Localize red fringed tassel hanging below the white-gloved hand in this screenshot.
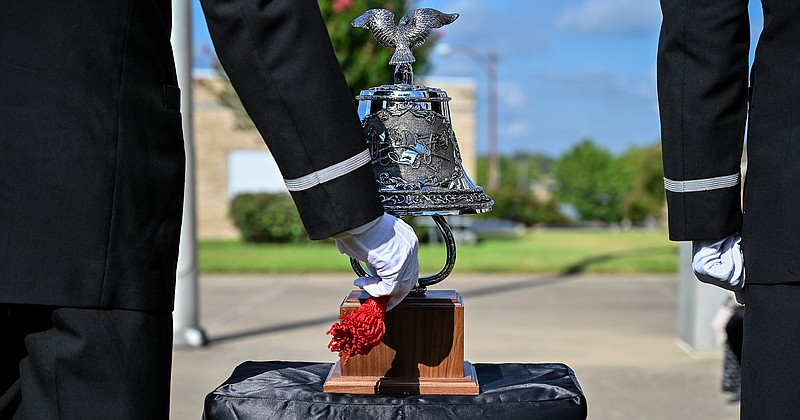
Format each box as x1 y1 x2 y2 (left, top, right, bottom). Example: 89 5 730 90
327 296 389 365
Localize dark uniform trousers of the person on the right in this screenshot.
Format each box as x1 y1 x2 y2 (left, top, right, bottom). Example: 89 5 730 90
741 284 800 420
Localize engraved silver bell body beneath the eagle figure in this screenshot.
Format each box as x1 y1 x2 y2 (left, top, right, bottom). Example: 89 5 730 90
357 65 492 216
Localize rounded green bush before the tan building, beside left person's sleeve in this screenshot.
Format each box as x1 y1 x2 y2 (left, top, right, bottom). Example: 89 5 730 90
230 193 309 243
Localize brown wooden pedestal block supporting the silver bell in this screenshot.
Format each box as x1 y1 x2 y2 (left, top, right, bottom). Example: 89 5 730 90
323 290 479 395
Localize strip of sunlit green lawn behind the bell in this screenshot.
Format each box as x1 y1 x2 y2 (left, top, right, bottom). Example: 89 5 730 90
199 229 678 276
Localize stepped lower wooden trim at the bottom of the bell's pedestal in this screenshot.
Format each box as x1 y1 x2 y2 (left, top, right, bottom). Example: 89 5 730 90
322 361 480 395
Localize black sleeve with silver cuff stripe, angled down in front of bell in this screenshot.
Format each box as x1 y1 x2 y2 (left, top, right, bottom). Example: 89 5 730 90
201 0 383 239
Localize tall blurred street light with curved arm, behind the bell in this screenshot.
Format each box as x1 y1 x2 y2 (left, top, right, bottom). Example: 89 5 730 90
436 44 500 191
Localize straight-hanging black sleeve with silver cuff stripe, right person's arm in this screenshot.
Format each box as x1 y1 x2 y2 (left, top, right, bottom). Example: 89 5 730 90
658 0 750 241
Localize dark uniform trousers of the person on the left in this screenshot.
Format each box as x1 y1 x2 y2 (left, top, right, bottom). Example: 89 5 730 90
0 304 172 419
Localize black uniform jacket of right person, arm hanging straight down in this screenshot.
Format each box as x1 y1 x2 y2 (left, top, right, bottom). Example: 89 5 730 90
658 0 800 283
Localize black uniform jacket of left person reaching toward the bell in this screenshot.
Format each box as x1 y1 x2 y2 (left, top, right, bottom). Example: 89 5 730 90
0 0 383 311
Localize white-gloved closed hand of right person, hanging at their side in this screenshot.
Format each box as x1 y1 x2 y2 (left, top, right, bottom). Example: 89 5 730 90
692 233 745 304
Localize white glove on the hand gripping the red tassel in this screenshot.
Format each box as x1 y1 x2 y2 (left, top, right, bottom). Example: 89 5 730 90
335 213 419 310
